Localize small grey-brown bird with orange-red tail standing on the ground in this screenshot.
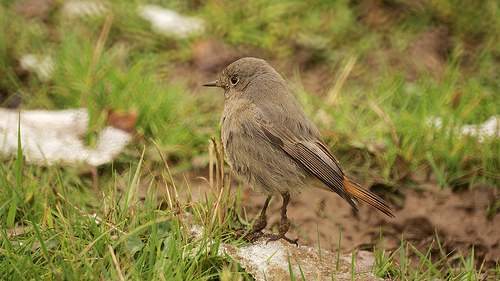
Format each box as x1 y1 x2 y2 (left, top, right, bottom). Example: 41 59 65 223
203 57 394 244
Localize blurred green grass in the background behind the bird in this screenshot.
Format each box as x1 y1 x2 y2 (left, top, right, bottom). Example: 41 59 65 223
0 0 500 187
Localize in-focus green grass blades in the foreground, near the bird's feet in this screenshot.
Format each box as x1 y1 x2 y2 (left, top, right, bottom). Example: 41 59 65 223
0 151 500 280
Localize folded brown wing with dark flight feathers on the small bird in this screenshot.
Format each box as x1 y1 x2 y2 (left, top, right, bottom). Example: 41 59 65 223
256 116 357 210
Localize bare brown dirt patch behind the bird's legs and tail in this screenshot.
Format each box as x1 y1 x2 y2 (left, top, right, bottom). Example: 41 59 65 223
165 166 500 268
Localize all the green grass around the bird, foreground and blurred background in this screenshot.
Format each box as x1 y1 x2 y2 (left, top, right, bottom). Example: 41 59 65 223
0 0 500 280
